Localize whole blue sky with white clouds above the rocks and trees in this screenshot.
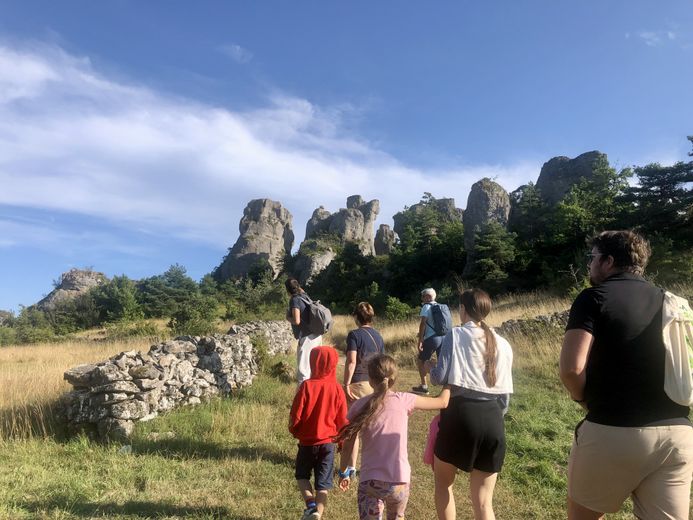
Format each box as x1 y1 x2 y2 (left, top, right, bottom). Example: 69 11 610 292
0 0 693 310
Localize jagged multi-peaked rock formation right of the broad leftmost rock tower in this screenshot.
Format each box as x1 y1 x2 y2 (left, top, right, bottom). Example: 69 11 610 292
294 195 380 284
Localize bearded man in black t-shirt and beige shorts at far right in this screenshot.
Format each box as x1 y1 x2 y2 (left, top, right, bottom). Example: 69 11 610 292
560 231 693 520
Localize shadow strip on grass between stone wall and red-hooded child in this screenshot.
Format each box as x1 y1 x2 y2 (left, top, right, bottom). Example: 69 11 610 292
132 439 294 466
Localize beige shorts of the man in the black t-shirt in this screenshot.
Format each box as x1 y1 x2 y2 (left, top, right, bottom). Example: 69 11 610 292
568 421 693 520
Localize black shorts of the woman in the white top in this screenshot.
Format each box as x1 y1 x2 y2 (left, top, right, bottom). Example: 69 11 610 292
433 397 505 473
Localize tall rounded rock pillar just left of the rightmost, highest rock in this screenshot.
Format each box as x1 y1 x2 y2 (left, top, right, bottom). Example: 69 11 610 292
462 178 510 276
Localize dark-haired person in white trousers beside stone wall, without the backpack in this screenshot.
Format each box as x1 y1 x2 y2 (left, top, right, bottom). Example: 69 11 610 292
284 278 322 385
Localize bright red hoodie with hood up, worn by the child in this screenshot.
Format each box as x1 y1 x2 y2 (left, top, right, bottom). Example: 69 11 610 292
289 347 348 446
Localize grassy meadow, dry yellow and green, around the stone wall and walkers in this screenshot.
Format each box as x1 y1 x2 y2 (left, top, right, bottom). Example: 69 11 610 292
0 294 676 520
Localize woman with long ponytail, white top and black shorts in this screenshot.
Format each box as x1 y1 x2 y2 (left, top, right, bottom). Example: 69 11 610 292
426 289 513 520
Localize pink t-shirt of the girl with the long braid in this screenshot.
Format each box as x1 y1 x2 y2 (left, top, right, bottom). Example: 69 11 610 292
347 392 416 482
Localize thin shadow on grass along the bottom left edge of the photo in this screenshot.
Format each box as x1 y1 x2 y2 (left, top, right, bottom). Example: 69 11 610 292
16 497 254 520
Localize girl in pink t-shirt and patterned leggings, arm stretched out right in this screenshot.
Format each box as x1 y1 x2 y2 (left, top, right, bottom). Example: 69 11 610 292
337 354 450 520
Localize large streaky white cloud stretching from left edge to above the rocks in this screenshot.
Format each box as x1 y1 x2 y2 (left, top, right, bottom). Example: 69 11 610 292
0 40 541 252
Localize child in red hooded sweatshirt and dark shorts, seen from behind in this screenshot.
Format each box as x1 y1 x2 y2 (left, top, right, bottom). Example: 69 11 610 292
289 346 347 520
